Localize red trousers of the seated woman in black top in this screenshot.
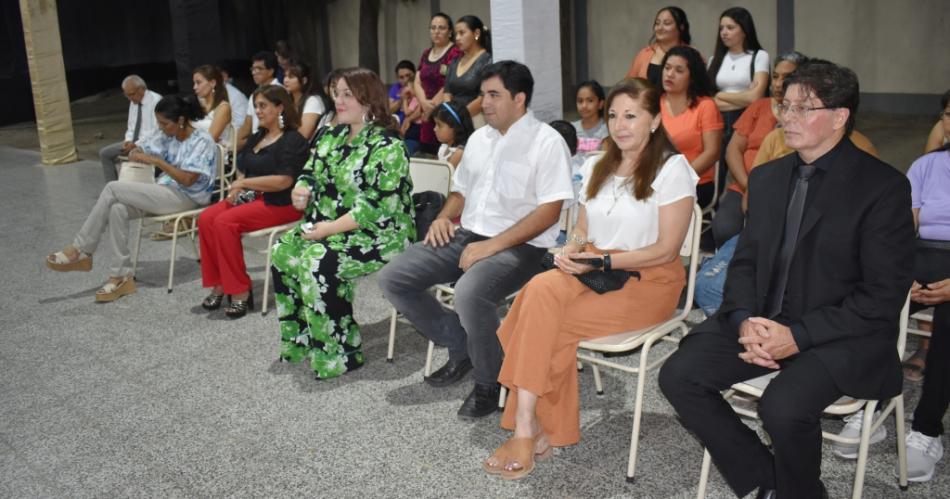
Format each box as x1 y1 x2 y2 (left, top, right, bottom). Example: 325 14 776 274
198 198 301 295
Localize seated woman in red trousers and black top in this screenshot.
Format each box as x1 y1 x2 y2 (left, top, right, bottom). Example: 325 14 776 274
198 85 307 318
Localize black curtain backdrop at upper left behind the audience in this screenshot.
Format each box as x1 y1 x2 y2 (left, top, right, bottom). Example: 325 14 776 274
0 0 333 125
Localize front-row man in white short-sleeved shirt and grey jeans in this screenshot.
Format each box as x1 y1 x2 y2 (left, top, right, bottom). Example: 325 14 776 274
379 61 573 417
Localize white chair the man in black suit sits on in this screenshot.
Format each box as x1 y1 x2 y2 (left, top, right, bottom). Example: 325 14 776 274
696 296 910 499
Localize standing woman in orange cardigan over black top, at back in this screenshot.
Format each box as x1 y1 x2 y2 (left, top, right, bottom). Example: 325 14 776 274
626 6 692 88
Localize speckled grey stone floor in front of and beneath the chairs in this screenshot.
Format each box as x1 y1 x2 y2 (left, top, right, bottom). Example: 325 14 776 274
0 142 950 499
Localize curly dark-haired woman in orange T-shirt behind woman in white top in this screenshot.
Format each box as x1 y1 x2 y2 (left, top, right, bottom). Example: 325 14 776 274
660 45 723 207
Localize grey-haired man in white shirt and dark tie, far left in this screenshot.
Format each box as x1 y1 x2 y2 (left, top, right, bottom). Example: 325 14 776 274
99 75 162 183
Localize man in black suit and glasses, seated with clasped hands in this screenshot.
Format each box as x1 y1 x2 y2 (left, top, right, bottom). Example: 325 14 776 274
659 61 914 499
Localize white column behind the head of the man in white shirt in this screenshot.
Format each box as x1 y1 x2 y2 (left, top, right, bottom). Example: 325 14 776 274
490 0 564 122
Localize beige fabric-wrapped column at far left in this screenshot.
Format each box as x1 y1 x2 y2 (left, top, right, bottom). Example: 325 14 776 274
20 0 78 165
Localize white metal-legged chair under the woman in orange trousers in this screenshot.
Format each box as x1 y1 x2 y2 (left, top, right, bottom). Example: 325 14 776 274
577 205 702 482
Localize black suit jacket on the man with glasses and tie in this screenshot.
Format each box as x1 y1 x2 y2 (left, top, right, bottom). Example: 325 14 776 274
693 139 914 399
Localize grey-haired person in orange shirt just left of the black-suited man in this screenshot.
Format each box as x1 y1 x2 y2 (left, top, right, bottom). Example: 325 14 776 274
712 52 808 248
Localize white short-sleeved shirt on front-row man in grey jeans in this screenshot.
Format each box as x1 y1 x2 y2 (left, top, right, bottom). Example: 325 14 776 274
452 111 574 248
